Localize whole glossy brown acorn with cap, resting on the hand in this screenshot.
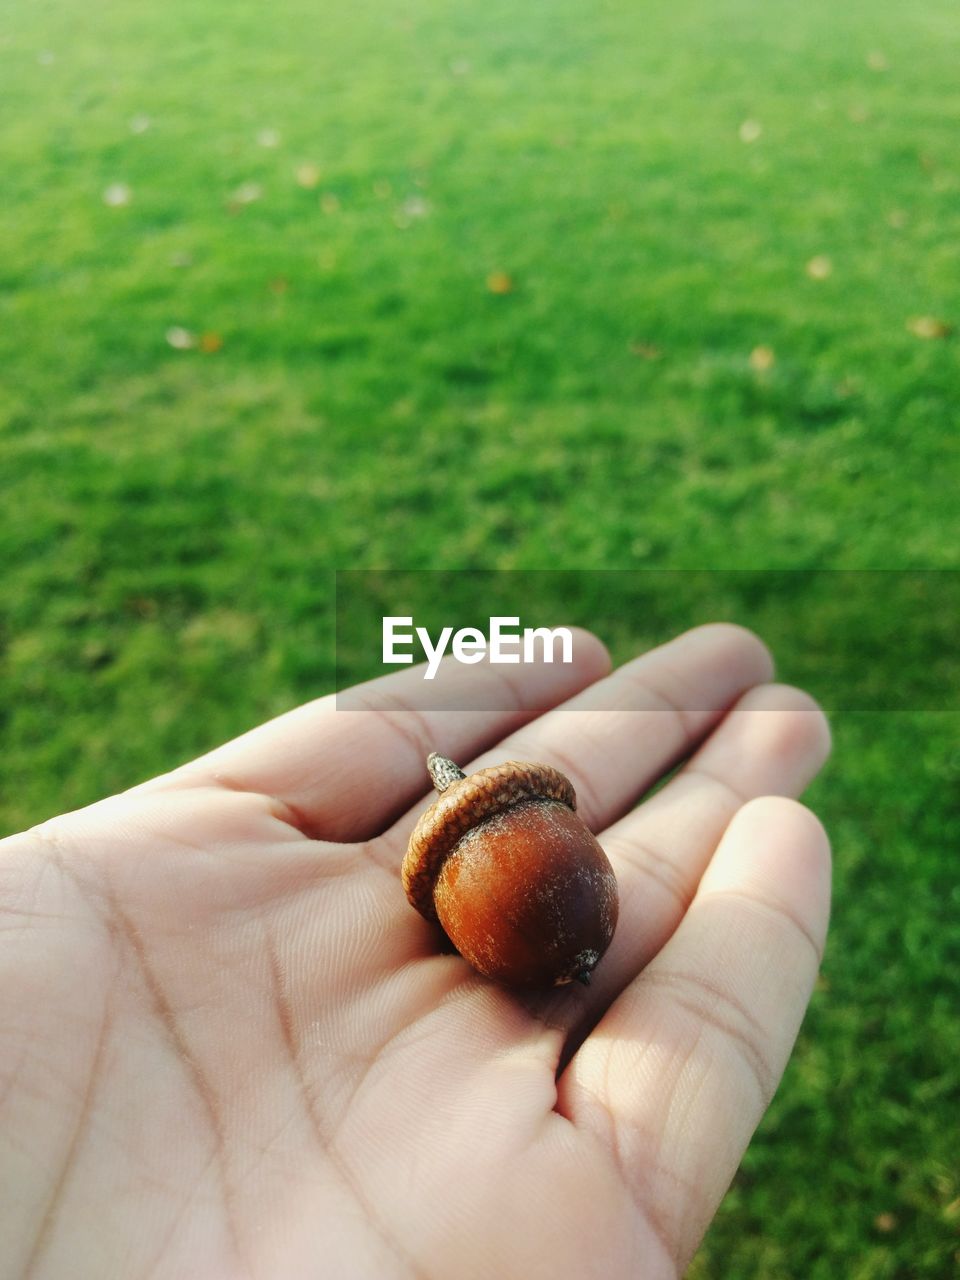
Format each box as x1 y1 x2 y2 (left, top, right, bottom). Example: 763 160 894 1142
402 753 620 987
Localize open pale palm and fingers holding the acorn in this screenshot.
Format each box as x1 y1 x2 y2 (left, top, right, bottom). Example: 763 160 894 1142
0 626 829 1280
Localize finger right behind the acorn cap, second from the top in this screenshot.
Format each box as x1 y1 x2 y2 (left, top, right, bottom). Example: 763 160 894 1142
390 623 773 849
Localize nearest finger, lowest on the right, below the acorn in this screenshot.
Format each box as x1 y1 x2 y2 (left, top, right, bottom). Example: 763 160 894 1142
558 797 829 1271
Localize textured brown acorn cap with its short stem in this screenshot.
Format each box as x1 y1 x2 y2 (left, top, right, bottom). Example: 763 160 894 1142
401 756 577 920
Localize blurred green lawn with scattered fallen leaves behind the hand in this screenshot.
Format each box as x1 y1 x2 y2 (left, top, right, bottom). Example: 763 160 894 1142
0 0 960 1280
